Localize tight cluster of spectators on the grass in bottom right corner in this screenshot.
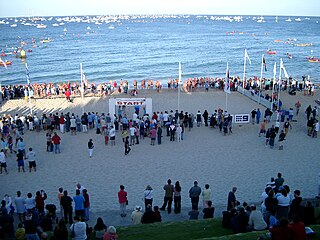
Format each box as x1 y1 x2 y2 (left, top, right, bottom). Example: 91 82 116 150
223 173 320 240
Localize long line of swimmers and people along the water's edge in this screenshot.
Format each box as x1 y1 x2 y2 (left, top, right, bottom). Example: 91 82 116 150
0 77 316 101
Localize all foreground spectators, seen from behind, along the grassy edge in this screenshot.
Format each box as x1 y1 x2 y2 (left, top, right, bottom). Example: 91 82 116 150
0 173 320 240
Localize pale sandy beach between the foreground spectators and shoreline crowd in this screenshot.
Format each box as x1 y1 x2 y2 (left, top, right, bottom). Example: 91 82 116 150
0 89 320 226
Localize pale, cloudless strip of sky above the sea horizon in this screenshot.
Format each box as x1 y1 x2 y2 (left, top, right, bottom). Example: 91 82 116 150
0 0 320 17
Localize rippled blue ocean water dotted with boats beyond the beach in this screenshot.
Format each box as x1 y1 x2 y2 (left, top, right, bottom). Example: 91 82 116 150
0 16 320 84
